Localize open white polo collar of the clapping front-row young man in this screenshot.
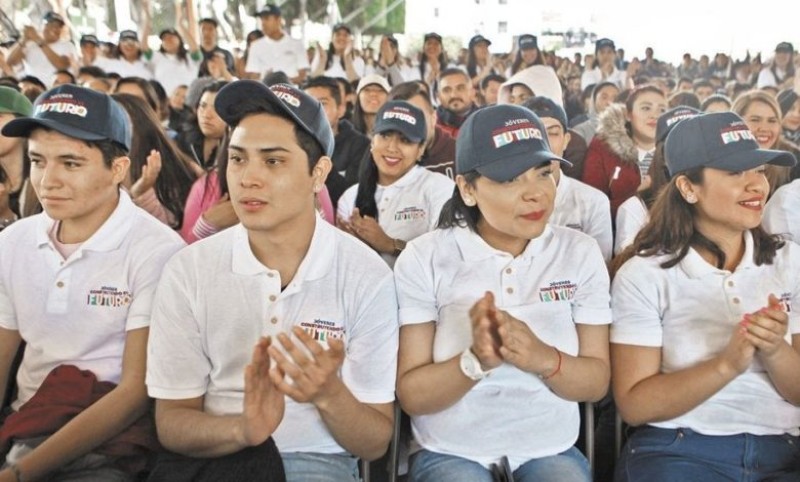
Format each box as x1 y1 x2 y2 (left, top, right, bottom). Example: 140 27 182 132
231 215 337 285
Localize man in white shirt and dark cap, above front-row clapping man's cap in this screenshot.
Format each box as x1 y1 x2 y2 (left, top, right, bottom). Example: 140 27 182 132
245 4 309 85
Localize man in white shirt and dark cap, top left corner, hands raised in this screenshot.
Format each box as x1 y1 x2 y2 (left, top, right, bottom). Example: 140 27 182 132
6 12 78 86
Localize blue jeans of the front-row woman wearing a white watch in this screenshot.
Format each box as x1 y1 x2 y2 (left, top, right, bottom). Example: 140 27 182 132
409 447 592 482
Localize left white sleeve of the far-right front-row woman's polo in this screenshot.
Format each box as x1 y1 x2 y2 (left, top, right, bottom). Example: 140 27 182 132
610 258 663 347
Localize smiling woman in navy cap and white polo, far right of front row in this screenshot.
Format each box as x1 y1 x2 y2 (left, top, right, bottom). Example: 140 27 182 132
611 112 800 482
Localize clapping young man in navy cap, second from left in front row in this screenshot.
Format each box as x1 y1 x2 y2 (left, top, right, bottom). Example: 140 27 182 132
147 80 397 482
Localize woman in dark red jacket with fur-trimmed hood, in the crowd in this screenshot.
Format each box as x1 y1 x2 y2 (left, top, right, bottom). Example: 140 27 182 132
581 85 667 220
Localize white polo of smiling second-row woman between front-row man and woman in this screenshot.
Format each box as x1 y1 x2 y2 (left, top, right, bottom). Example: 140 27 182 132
336 165 455 266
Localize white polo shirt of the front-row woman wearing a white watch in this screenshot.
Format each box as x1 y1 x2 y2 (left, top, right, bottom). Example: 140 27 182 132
394 225 611 469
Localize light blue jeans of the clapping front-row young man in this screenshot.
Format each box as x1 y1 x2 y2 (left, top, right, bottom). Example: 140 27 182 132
281 452 359 482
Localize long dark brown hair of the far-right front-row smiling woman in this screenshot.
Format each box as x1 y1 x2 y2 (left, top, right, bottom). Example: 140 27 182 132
611 167 785 274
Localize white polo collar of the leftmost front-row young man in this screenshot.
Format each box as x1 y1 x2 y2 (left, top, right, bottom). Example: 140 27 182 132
36 189 137 252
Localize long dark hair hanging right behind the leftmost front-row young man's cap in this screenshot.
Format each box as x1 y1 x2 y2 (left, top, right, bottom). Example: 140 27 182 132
113 94 195 229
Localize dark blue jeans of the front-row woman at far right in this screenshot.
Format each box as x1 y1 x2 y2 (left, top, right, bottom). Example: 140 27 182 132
615 426 800 482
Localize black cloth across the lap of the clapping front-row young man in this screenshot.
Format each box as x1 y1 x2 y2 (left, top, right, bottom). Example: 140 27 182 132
147 437 286 482
